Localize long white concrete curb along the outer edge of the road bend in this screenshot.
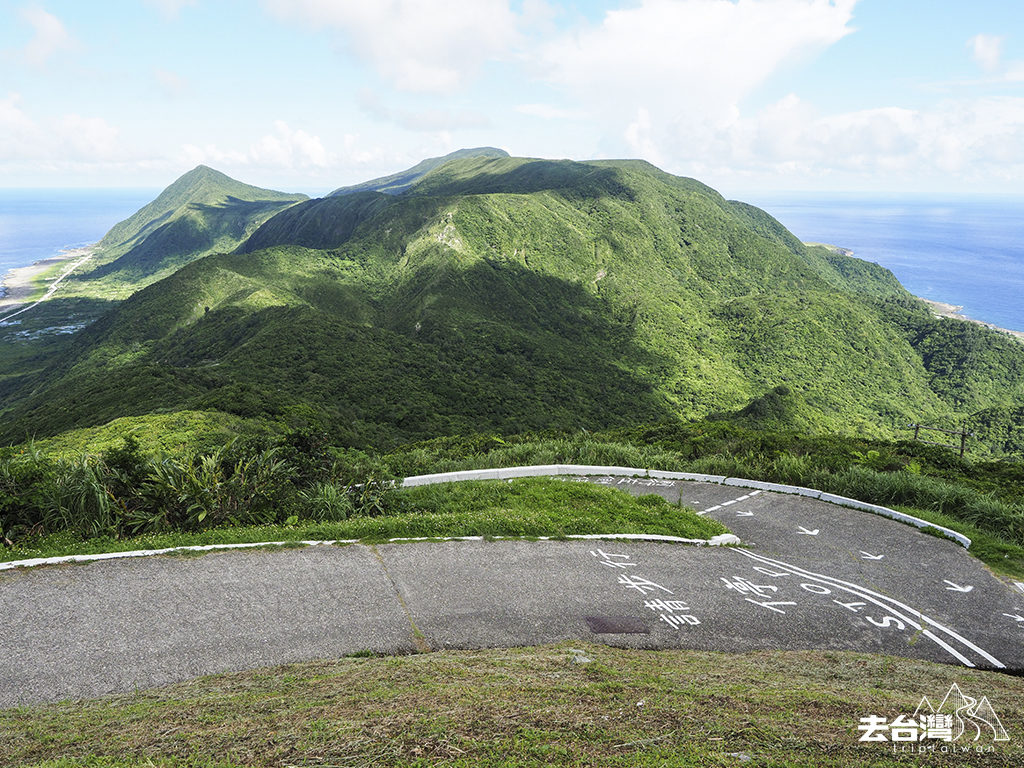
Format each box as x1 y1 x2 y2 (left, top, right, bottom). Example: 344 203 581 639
399 464 971 549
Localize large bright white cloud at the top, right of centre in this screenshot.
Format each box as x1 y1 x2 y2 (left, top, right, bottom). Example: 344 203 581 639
535 0 856 124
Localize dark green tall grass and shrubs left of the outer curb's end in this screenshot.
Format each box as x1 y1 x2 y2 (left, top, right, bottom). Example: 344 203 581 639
0 440 388 545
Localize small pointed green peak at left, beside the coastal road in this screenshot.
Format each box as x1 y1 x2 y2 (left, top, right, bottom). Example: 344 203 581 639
72 165 308 295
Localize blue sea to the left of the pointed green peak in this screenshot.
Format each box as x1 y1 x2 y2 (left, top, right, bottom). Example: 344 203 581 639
0 188 159 278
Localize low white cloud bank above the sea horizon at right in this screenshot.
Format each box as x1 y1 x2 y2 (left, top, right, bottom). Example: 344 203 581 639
688 94 1024 188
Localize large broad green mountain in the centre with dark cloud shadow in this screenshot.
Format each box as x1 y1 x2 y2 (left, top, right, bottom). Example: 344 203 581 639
0 157 1024 456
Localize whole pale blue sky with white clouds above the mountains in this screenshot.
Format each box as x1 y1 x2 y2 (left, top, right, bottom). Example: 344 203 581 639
0 0 1024 197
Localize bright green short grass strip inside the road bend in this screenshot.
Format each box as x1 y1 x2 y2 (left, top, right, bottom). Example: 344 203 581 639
0 478 728 561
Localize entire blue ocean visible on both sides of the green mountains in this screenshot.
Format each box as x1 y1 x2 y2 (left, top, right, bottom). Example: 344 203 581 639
0 189 1024 331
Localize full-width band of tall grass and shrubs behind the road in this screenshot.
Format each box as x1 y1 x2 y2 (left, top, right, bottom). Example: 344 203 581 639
0 426 1024 545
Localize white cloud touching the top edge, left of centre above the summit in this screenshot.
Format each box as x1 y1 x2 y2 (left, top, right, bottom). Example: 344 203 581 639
264 0 524 92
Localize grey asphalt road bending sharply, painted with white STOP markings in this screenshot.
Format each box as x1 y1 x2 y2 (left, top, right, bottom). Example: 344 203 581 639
0 475 1024 707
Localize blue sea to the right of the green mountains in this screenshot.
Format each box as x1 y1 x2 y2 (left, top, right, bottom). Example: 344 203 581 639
748 195 1024 331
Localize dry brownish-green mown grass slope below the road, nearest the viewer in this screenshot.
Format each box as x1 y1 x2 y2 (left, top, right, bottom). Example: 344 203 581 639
0 644 1024 768
